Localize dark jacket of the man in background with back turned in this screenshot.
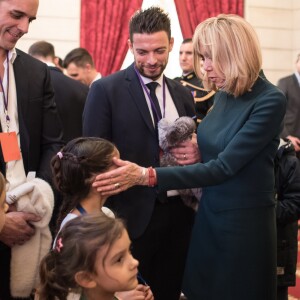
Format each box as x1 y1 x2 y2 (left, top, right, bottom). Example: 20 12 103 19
49 67 89 143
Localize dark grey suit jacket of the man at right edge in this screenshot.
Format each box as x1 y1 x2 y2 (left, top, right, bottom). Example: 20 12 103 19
278 74 300 138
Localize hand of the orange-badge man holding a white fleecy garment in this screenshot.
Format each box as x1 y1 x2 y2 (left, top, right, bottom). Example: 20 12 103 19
0 212 41 247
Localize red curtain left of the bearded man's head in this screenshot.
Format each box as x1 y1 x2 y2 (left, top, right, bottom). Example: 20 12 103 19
80 0 142 76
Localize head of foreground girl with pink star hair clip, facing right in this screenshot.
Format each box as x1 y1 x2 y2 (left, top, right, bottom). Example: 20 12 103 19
37 213 138 300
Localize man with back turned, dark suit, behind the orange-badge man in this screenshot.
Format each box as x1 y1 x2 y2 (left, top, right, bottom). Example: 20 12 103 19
28 41 89 143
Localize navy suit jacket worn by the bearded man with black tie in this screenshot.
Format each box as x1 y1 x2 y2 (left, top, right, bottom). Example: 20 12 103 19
83 65 195 238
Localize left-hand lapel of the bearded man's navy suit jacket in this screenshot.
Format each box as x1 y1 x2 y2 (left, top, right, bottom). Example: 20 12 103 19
125 64 156 136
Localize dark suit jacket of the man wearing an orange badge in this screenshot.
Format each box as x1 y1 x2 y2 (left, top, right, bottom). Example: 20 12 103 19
0 50 62 182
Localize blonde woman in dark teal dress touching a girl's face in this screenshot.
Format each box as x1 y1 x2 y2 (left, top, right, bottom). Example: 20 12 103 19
94 15 286 300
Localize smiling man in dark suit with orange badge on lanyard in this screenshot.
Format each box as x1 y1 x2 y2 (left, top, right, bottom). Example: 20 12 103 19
0 0 62 300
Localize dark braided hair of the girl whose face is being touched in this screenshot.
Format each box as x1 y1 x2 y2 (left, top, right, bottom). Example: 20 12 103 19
51 137 116 229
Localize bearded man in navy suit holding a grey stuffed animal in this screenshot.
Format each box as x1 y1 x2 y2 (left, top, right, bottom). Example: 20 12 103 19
83 7 199 300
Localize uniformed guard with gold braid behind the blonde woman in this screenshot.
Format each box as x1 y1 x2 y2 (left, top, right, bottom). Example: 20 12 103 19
174 38 215 123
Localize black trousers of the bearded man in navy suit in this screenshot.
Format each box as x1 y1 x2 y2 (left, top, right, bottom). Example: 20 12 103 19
132 196 195 300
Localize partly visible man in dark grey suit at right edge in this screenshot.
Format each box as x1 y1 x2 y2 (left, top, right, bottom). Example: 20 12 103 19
278 54 300 158
